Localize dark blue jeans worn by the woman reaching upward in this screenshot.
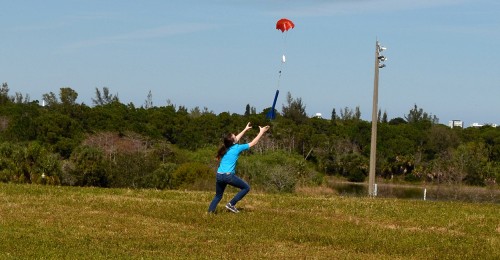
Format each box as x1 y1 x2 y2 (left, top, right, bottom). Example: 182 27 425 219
208 173 250 212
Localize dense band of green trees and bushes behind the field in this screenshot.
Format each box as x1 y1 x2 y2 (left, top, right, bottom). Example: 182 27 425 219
0 83 500 191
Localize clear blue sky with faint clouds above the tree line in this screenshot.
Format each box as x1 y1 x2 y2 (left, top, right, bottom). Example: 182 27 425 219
0 0 500 126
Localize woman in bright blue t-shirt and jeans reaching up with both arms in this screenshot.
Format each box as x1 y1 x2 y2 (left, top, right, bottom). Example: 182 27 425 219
208 123 269 213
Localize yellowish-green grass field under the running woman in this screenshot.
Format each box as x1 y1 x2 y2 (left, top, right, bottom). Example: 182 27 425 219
0 184 500 259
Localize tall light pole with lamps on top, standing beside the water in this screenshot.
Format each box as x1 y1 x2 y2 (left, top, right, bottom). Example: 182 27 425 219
368 40 387 197
